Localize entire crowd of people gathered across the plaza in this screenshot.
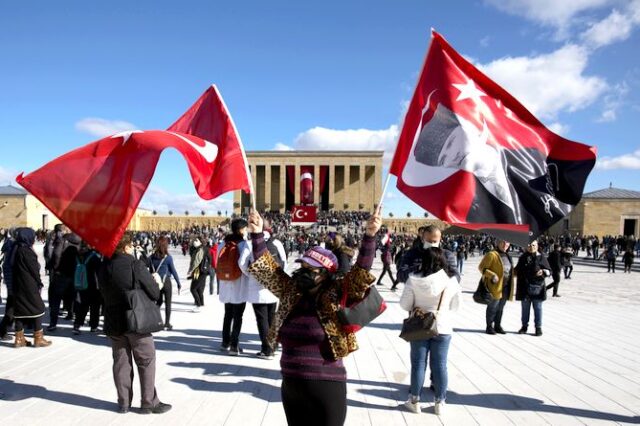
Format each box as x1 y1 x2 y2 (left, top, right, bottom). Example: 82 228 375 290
0 216 640 425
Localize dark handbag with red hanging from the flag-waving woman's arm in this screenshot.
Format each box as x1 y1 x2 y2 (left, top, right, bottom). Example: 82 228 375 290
337 282 387 333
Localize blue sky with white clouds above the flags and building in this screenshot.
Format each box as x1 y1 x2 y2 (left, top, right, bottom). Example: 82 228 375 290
0 0 640 215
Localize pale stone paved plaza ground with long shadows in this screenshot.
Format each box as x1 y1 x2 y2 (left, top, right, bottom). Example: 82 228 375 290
0 243 640 426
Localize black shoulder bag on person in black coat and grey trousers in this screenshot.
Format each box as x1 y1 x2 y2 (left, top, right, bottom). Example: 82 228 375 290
126 261 164 334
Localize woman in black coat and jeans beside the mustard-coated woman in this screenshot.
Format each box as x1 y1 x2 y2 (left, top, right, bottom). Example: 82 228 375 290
515 241 551 336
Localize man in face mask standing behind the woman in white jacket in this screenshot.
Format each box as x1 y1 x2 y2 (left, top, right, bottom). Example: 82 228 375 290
391 225 460 291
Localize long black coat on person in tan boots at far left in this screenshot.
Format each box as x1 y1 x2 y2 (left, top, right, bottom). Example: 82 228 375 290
12 245 45 318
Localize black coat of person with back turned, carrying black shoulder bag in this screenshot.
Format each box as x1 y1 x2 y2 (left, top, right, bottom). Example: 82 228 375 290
99 253 160 336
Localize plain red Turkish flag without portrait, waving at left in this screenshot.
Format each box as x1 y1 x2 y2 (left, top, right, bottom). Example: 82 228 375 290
16 86 250 256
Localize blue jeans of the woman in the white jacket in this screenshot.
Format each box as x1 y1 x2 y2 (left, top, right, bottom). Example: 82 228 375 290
409 334 451 401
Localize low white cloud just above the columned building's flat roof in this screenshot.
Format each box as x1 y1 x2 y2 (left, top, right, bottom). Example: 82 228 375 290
294 124 399 166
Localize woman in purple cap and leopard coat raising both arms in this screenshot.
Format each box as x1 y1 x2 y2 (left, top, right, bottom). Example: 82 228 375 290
249 209 382 426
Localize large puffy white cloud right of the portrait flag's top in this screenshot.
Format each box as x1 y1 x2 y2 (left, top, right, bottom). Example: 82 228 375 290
478 44 608 118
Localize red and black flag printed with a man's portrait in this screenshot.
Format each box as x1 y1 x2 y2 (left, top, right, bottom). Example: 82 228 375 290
390 32 596 245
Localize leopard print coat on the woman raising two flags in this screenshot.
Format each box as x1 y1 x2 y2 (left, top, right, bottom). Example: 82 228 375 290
249 252 375 360
